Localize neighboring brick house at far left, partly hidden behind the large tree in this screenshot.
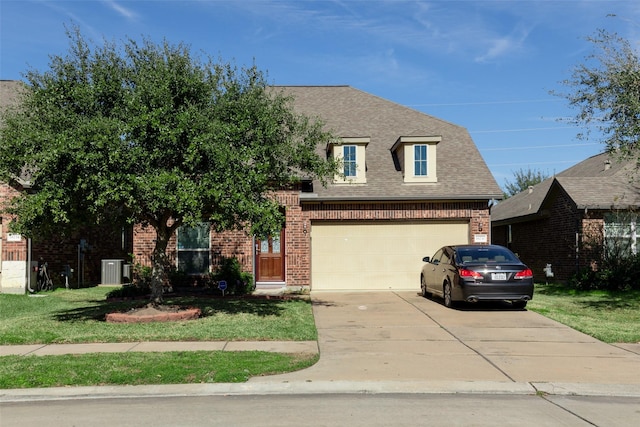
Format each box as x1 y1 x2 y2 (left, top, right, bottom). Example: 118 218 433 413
0 80 132 293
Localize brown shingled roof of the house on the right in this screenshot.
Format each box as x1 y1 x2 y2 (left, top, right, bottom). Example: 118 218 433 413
491 153 640 224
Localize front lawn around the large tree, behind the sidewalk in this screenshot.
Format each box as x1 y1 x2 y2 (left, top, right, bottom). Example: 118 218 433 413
0 287 317 344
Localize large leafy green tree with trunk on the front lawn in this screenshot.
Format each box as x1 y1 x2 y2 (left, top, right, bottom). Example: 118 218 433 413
0 28 337 303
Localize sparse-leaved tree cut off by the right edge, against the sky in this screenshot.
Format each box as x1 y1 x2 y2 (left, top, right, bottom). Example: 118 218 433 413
554 30 640 165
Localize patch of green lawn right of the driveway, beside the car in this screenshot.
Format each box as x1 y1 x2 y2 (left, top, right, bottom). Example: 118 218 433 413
527 284 640 343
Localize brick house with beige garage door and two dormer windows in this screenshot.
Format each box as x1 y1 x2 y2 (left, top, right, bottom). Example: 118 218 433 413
134 86 502 291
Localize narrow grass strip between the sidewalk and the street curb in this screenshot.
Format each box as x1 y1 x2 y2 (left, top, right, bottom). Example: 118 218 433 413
0 351 318 389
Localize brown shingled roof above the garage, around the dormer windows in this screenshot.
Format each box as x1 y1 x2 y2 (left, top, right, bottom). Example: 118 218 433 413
277 86 502 200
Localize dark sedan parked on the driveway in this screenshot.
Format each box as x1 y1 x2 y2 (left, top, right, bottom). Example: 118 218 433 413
420 245 533 308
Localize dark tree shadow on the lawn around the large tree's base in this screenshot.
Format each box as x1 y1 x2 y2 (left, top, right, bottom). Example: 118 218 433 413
54 296 302 322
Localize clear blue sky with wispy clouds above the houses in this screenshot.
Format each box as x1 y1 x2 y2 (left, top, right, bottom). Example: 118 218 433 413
0 0 640 191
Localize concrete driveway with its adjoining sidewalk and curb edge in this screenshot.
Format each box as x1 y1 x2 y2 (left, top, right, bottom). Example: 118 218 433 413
0 291 640 402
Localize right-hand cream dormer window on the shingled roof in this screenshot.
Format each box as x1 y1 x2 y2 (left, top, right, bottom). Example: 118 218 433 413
391 136 442 183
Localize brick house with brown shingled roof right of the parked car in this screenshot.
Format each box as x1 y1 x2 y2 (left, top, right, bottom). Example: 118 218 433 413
491 154 640 281
